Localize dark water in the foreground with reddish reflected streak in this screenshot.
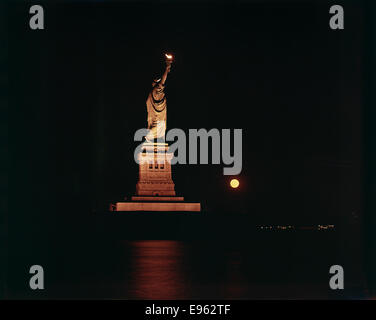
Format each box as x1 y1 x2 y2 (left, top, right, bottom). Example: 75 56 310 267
7 226 365 299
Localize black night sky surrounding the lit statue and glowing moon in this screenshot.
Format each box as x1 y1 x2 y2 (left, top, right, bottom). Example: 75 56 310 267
9 1 364 230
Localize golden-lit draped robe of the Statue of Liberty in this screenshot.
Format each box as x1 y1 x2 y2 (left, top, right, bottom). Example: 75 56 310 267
145 83 167 142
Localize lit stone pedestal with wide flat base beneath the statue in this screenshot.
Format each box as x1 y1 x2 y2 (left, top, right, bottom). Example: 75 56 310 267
110 142 201 212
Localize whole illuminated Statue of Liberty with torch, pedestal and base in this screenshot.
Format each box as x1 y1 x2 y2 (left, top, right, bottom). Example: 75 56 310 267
110 54 201 212
